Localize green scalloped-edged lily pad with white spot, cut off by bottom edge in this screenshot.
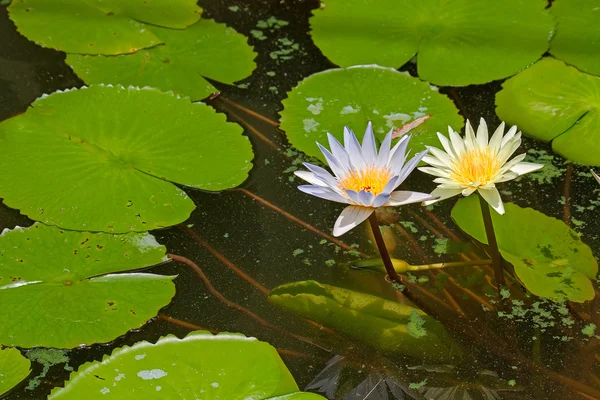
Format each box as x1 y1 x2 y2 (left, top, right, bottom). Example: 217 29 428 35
48 331 323 400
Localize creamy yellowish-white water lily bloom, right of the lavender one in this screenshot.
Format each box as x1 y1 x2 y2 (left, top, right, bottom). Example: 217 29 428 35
419 118 544 214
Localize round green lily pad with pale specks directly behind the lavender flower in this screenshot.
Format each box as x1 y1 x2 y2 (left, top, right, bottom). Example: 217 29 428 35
281 65 463 161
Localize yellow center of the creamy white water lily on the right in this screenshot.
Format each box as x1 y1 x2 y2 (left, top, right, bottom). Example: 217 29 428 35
451 147 502 186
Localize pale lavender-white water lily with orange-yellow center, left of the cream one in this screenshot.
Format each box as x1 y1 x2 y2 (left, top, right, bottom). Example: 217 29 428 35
295 122 434 236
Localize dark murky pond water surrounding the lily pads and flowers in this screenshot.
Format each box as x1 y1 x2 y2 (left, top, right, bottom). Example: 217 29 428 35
0 0 600 400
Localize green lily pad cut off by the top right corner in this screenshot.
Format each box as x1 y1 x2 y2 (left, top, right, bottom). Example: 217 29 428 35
550 0 600 75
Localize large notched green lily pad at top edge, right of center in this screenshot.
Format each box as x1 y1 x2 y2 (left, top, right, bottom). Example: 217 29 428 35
310 0 554 86
